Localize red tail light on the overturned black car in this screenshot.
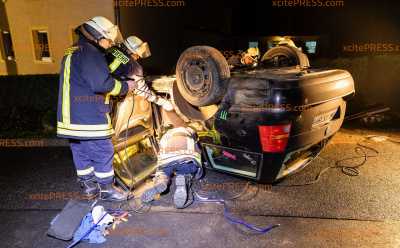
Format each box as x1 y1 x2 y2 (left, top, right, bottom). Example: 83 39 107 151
258 124 291 152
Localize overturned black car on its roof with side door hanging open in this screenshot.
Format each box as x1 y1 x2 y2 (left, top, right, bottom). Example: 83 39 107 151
113 45 354 189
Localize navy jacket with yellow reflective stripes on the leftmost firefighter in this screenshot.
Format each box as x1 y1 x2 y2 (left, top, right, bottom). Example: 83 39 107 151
57 37 128 140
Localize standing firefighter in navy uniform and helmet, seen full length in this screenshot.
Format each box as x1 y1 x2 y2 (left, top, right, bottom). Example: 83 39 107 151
57 16 135 201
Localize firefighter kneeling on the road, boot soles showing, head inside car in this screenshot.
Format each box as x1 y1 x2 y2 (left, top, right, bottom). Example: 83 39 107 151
141 127 203 208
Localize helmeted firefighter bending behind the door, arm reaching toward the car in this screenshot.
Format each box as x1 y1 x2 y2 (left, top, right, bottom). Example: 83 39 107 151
106 36 173 111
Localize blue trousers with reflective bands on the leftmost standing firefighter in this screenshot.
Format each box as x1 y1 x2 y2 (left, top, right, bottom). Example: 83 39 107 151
70 139 114 184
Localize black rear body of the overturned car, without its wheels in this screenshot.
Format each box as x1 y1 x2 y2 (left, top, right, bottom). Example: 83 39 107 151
205 68 354 183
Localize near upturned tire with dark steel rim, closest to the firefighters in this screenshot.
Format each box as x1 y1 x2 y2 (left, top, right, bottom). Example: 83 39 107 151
176 46 230 107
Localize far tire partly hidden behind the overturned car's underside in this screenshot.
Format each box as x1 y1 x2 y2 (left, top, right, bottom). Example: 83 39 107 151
261 45 310 68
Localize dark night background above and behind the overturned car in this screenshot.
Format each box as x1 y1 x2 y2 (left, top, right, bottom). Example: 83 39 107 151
119 0 400 111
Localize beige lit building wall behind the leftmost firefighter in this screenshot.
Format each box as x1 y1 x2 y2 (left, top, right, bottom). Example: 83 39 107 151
4 0 115 74
